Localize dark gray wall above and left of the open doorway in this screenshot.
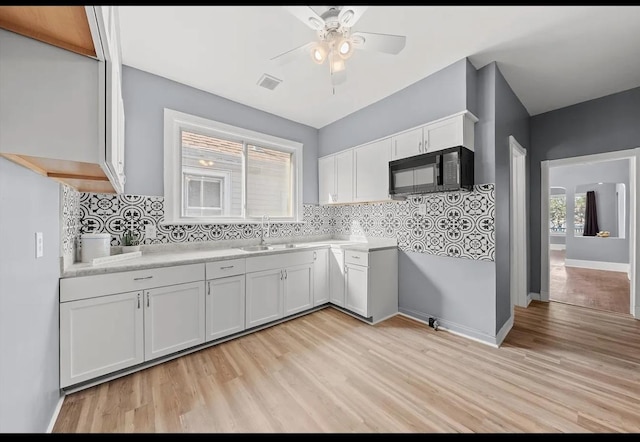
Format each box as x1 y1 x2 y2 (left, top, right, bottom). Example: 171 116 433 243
529 88 640 292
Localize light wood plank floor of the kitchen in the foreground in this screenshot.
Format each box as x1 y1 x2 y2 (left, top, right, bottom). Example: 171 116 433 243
54 301 640 433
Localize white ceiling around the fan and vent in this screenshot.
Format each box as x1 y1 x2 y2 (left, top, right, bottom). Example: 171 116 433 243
119 6 640 128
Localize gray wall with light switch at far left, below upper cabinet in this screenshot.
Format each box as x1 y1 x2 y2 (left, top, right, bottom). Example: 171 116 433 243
0 158 60 433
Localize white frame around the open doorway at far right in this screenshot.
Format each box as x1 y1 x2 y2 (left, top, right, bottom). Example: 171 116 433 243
540 147 640 319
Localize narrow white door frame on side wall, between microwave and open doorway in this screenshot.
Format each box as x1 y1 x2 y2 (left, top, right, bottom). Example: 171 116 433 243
509 135 531 313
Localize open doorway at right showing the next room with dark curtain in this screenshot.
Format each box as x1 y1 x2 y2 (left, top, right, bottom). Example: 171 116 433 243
541 149 639 317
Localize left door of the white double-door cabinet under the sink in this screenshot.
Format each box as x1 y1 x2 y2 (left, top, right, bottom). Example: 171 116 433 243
245 269 284 328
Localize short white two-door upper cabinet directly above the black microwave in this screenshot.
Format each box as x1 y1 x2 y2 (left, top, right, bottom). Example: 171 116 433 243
391 111 478 160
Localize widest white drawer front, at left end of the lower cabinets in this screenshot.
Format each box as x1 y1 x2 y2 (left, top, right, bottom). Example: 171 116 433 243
60 263 204 302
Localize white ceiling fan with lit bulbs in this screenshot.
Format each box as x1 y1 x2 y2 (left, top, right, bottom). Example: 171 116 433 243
271 6 407 93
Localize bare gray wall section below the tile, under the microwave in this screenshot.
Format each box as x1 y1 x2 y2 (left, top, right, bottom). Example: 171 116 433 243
398 250 496 341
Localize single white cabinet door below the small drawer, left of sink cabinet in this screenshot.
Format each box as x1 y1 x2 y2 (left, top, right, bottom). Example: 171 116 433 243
205 275 245 341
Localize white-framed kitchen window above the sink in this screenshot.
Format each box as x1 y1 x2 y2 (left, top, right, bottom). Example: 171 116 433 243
164 109 302 224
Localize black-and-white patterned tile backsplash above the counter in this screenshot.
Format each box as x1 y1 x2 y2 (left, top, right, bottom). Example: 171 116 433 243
75 184 495 261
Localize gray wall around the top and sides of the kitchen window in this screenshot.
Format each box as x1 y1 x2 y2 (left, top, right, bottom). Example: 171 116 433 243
122 66 318 204
